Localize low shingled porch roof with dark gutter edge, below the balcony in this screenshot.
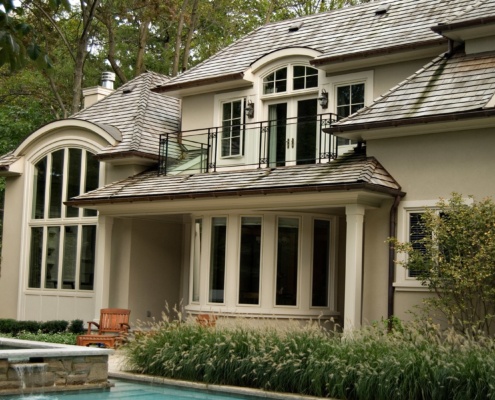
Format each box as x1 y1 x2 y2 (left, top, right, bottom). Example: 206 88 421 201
67 152 402 206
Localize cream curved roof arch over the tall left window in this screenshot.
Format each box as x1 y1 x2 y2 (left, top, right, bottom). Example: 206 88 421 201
13 119 122 156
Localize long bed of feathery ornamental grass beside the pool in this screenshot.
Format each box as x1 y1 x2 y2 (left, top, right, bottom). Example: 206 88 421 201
124 319 495 399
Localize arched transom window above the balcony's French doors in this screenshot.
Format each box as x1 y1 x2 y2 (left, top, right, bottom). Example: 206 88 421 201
263 65 318 94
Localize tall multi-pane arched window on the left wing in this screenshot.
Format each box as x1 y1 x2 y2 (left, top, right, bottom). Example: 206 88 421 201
27 148 100 290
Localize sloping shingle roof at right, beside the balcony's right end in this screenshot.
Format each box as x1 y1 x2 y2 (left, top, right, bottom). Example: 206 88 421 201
330 49 495 132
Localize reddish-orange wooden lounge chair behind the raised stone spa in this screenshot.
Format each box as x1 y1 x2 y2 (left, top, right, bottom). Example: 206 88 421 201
77 308 131 348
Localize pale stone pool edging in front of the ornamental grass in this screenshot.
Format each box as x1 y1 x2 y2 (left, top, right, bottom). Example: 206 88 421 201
108 371 337 400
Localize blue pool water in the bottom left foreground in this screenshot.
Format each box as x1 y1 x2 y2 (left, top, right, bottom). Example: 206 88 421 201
0 379 261 400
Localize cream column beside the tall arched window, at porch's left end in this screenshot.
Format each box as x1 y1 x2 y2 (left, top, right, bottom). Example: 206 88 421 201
94 216 113 319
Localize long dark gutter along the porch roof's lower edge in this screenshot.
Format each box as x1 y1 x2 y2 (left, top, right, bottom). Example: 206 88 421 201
64 182 405 207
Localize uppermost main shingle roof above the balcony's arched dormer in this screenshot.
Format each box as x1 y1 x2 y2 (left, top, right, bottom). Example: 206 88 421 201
156 0 480 92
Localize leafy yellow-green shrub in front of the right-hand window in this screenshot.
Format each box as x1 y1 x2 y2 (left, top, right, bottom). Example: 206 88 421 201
392 193 495 334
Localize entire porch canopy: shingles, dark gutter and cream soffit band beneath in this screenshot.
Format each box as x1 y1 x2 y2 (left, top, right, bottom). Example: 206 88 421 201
66 151 404 212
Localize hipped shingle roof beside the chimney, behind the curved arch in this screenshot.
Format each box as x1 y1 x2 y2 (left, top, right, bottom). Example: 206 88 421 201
71 72 180 157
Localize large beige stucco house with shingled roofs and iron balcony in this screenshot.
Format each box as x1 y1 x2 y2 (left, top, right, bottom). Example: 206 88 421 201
0 0 495 328
